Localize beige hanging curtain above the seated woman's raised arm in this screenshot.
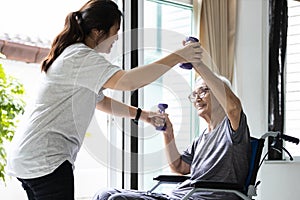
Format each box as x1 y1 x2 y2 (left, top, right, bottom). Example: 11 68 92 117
193 0 237 82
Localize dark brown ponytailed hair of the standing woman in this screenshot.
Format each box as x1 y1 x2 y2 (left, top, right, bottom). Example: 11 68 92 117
41 0 122 72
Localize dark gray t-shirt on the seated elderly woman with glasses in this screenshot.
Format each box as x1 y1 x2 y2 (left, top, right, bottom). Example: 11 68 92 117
172 112 251 200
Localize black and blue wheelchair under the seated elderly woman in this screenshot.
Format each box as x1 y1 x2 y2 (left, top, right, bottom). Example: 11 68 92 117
148 132 299 200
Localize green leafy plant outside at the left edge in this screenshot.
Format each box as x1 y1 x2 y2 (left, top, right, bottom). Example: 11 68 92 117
0 63 25 182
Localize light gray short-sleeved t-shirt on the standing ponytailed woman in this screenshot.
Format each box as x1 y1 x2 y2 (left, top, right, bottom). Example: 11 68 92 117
6 43 120 178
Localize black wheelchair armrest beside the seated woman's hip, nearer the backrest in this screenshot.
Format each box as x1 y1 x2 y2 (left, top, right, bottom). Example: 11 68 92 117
191 180 244 192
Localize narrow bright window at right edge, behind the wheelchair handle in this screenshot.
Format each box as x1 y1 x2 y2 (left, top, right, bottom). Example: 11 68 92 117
285 0 300 156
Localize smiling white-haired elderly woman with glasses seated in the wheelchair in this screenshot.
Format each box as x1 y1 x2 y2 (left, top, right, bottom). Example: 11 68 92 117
95 52 251 200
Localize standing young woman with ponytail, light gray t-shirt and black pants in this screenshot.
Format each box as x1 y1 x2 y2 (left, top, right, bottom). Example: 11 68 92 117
7 0 201 200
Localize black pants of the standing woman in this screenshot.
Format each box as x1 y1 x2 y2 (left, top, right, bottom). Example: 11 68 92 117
18 161 74 200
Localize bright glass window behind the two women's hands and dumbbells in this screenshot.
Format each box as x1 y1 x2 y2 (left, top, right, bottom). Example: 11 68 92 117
139 0 195 189
